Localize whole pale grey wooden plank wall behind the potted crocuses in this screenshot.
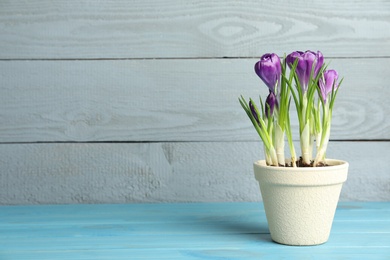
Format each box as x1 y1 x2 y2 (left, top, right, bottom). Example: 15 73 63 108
0 0 390 204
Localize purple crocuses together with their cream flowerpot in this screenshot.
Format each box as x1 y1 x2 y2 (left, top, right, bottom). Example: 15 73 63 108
239 51 348 245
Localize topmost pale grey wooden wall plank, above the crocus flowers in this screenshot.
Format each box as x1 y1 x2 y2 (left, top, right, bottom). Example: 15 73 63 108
0 0 390 59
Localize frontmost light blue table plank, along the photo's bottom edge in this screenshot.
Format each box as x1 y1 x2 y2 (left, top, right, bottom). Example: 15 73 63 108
1 246 389 260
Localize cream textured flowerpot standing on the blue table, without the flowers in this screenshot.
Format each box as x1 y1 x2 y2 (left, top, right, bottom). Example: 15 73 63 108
254 159 348 245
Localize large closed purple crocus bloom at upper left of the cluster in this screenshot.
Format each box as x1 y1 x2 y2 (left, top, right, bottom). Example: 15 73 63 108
255 53 282 93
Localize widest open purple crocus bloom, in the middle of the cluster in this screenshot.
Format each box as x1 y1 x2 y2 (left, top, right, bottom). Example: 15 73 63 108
286 51 324 93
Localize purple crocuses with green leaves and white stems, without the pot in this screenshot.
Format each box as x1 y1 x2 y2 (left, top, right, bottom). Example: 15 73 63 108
239 51 342 167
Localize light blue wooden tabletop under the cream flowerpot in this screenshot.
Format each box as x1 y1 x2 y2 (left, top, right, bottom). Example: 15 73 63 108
0 202 390 260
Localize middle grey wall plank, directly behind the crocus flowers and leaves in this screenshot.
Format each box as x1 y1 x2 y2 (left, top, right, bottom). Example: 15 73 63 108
0 59 390 142
